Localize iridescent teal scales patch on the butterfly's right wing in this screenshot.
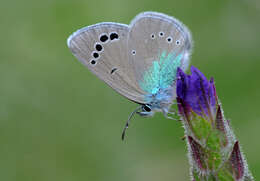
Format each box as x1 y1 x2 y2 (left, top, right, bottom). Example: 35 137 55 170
139 51 182 95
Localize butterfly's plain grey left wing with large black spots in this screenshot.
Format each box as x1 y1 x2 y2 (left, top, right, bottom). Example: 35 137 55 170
67 23 143 103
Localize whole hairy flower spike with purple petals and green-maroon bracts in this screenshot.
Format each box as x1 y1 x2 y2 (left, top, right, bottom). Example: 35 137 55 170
176 67 254 181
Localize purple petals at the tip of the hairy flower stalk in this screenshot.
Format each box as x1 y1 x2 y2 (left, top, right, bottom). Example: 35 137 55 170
177 66 217 119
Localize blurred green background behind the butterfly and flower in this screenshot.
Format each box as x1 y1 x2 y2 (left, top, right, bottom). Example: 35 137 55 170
0 0 260 181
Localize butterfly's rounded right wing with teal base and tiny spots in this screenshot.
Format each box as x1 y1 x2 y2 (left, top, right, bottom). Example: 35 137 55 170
128 12 192 94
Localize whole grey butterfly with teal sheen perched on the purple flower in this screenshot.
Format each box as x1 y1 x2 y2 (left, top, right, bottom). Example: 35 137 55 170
67 12 192 139
